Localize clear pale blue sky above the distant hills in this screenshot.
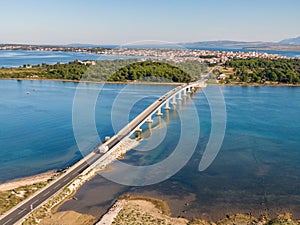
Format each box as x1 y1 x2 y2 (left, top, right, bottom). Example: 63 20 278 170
0 0 300 45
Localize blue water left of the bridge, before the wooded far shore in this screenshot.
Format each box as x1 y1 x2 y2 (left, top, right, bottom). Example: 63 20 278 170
0 80 171 182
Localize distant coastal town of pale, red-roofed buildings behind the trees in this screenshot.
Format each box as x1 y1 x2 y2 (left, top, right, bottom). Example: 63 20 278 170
0 45 287 64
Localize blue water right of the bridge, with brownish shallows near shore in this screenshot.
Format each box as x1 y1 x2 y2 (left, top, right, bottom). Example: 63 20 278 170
60 82 300 220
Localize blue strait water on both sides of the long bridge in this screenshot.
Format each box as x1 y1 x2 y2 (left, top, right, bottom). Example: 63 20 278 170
0 80 300 218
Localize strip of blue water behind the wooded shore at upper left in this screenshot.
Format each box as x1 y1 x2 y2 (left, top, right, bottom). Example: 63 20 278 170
0 50 132 68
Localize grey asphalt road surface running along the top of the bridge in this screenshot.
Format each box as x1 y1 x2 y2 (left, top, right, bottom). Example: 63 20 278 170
0 84 198 225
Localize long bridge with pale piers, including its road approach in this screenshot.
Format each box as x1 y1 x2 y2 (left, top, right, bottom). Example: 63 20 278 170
0 78 209 225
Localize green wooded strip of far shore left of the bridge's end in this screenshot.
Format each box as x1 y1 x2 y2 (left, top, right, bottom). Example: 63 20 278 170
0 59 206 82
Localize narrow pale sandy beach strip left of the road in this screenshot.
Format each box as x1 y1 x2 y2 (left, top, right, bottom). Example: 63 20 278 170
0 171 57 191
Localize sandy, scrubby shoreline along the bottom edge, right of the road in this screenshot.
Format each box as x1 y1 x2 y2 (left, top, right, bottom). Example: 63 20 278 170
96 195 300 225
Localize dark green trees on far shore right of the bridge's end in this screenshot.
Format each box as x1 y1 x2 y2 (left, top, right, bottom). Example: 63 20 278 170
218 58 300 84
